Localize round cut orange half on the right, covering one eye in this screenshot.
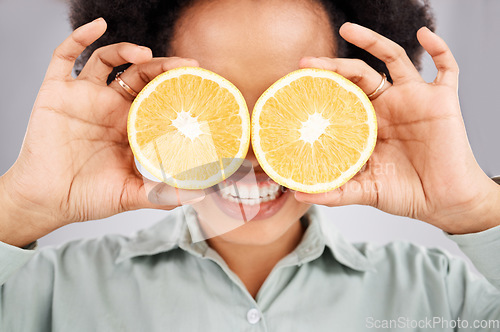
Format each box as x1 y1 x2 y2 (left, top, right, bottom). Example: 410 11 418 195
252 68 377 193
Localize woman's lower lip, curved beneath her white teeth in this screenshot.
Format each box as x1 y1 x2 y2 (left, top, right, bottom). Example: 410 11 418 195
213 187 290 222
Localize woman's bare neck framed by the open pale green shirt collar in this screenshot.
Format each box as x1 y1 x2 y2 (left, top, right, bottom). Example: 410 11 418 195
207 220 304 298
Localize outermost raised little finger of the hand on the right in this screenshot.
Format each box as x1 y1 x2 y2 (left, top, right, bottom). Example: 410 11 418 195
417 27 459 88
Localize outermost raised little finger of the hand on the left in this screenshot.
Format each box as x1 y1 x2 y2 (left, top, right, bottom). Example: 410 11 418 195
45 18 107 79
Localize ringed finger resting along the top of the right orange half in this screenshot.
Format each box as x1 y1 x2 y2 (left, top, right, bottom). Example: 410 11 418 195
299 57 391 100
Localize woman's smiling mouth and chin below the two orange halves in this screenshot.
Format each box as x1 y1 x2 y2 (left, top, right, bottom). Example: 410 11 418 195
193 175 311 246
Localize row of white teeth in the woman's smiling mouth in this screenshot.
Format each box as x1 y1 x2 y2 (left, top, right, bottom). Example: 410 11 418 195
219 183 281 205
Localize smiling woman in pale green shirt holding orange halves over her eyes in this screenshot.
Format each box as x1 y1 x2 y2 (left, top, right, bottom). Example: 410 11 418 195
0 0 500 331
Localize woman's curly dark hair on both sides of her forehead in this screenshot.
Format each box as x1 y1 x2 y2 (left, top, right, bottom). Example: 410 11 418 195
70 0 434 82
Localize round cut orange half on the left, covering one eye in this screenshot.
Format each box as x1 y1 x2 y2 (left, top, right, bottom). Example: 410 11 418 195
127 67 250 189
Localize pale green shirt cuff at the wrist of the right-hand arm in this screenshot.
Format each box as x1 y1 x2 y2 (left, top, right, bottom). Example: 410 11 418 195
445 226 500 290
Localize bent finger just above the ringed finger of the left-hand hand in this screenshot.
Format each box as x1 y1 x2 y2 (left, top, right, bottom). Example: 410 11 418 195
78 42 153 85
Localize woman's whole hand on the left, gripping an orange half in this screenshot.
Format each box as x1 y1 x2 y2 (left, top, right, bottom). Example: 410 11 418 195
0 19 204 246
